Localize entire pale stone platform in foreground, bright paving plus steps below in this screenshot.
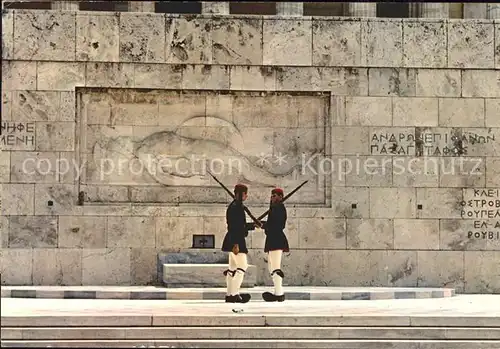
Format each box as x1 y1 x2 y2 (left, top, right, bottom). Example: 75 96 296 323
1 295 500 349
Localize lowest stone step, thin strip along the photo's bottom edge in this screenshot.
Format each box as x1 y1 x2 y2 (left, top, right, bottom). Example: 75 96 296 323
1 339 500 349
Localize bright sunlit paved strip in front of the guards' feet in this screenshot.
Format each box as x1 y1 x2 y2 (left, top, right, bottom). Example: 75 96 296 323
1 295 500 322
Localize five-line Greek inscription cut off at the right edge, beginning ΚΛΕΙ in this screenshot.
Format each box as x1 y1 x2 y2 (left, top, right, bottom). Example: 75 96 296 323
461 189 500 240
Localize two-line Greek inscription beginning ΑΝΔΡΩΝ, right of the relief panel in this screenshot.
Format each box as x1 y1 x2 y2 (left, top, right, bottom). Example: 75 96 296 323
370 127 495 156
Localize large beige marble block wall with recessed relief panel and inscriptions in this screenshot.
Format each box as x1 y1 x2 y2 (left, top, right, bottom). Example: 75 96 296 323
0 10 500 293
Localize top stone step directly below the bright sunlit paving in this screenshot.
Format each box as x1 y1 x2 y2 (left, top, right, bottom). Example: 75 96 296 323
0 312 500 328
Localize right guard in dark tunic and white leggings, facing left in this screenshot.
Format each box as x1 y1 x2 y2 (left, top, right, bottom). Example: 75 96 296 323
262 188 290 302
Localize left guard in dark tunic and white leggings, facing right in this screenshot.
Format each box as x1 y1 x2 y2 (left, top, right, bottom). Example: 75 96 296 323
222 184 257 303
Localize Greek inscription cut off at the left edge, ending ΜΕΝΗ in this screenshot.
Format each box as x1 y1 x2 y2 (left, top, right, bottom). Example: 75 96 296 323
0 121 35 150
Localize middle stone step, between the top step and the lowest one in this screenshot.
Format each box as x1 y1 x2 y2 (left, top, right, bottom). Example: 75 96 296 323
1 326 500 340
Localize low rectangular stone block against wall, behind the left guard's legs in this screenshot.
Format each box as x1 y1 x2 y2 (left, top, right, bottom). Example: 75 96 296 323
162 263 257 287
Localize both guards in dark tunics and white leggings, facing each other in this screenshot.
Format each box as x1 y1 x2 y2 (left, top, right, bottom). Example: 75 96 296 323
222 184 289 303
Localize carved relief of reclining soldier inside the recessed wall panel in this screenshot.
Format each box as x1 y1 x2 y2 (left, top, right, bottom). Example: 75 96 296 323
83 117 323 204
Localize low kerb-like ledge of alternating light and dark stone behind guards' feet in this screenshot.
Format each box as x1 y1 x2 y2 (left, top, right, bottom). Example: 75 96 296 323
1 286 455 300
